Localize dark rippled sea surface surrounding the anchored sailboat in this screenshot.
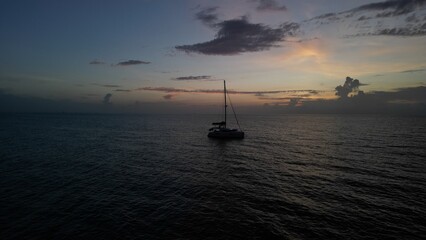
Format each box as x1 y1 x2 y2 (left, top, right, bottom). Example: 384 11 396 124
0 114 426 239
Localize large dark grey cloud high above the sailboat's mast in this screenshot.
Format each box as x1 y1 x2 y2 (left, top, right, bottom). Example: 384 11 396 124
175 17 299 55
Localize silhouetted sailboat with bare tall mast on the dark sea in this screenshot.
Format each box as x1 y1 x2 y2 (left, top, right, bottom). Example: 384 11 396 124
207 80 244 139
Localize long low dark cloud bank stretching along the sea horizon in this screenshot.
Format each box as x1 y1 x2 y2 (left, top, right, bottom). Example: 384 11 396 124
0 86 426 116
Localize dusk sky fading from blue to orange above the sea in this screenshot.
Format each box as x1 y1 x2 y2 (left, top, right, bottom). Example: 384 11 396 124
0 0 426 114
